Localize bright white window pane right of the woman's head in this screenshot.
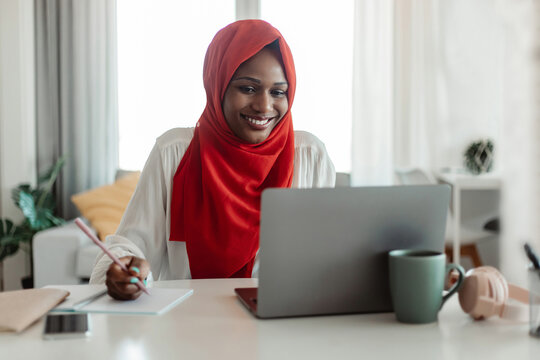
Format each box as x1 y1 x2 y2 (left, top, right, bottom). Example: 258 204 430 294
261 0 354 172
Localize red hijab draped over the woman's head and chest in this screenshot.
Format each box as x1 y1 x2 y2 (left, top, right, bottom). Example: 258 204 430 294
170 20 296 279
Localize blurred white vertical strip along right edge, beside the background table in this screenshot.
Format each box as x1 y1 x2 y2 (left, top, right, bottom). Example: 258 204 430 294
501 0 540 286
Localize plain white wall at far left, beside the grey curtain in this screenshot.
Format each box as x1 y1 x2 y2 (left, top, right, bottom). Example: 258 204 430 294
0 0 36 290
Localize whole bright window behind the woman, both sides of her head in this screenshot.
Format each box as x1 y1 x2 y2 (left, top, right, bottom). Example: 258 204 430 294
118 0 354 172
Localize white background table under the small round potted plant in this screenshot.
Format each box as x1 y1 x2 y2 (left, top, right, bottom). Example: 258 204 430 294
436 173 501 264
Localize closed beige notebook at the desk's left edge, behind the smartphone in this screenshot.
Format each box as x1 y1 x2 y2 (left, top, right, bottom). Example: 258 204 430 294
0 289 69 332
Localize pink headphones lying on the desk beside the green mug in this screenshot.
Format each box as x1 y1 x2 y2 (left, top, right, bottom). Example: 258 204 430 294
459 266 529 321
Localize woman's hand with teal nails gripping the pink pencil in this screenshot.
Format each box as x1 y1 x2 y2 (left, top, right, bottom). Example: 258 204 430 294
105 256 150 300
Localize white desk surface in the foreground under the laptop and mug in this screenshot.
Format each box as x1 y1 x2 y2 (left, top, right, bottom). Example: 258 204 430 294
0 279 540 360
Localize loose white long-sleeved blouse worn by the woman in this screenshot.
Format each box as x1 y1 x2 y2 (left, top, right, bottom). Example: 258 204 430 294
90 128 336 283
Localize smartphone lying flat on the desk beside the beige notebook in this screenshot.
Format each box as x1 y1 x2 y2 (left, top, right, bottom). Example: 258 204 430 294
43 313 90 340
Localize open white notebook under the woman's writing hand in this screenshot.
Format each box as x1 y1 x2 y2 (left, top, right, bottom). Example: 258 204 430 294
46 285 193 315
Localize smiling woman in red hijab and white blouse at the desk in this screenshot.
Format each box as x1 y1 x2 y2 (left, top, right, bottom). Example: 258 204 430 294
91 20 335 300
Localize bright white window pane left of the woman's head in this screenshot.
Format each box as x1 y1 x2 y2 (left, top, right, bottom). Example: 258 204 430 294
118 0 235 169
